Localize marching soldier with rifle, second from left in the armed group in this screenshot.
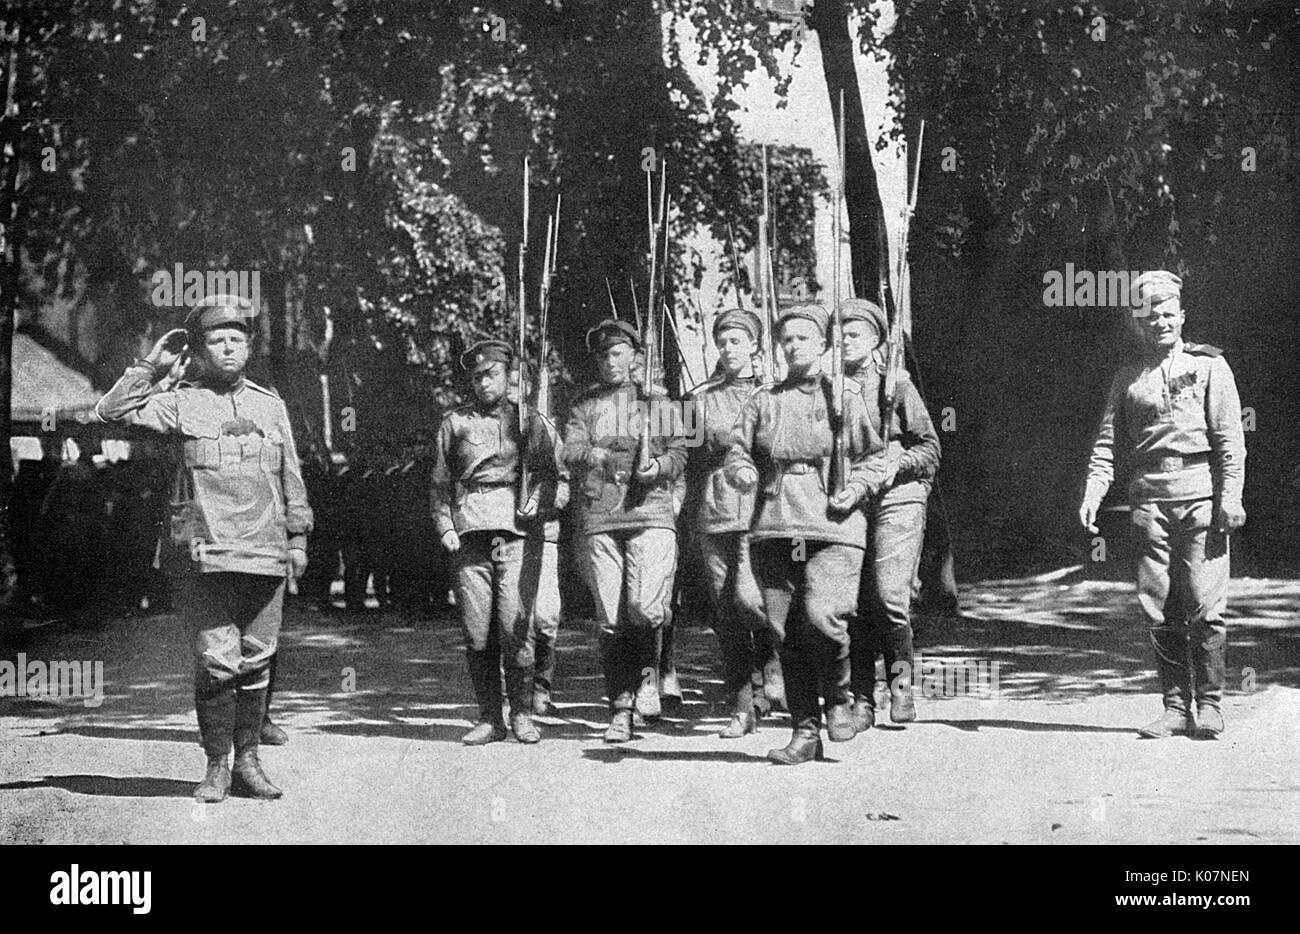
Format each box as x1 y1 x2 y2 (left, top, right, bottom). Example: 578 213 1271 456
564 320 686 743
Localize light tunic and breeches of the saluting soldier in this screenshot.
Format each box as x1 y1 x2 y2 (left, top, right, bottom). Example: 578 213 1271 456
95 362 312 693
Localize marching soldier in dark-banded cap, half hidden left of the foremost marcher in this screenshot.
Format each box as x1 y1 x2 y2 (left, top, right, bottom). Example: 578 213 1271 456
685 308 785 739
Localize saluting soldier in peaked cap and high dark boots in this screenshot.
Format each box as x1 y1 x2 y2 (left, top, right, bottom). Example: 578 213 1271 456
95 294 312 803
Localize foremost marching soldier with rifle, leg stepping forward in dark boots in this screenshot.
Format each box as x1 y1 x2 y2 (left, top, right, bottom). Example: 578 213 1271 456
725 304 884 765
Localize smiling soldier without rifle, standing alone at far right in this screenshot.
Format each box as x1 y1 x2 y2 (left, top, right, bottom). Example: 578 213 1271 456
1079 271 1245 739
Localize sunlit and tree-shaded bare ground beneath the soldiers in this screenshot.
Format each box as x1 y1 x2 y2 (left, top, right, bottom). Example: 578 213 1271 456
0 575 1300 843
